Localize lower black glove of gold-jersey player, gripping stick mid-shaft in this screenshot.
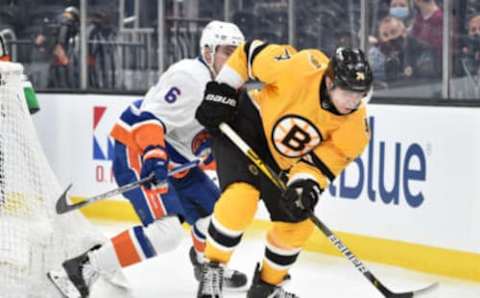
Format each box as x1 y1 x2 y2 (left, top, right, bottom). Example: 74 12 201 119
281 179 323 222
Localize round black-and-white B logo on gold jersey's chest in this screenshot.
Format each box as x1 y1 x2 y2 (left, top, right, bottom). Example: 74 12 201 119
272 115 322 158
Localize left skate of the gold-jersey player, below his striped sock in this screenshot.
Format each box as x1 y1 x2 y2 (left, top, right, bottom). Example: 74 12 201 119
197 262 224 298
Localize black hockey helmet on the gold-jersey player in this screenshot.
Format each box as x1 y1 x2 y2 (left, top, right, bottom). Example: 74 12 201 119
327 47 373 93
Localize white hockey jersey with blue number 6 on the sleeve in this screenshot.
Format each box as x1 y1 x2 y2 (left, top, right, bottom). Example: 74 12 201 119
112 58 212 161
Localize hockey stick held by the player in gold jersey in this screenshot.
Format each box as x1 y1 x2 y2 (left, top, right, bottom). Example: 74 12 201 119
219 123 437 298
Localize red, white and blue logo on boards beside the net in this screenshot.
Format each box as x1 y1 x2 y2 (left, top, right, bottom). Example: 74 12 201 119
92 106 115 160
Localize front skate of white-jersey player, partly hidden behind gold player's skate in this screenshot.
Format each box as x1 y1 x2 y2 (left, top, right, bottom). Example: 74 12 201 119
189 246 247 291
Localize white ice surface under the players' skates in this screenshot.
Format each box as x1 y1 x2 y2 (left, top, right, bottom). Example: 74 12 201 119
92 223 480 298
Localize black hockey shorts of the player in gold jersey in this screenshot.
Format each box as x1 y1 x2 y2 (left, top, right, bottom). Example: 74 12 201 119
213 92 292 222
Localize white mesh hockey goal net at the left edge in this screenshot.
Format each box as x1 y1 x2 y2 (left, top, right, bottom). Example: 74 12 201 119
0 62 103 298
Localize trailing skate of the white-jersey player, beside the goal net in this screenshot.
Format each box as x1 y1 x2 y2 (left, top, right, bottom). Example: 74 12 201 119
47 246 99 298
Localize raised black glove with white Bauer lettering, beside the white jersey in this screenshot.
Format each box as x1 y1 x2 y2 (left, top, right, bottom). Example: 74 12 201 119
195 81 238 133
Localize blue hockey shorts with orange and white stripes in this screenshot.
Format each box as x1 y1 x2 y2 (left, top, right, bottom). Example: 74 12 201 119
113 141 220 226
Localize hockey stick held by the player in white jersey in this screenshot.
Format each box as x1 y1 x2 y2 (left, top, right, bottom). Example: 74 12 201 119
56 160 200 214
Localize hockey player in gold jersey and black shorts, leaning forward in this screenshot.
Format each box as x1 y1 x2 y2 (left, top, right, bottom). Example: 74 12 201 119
196 41 373 298
